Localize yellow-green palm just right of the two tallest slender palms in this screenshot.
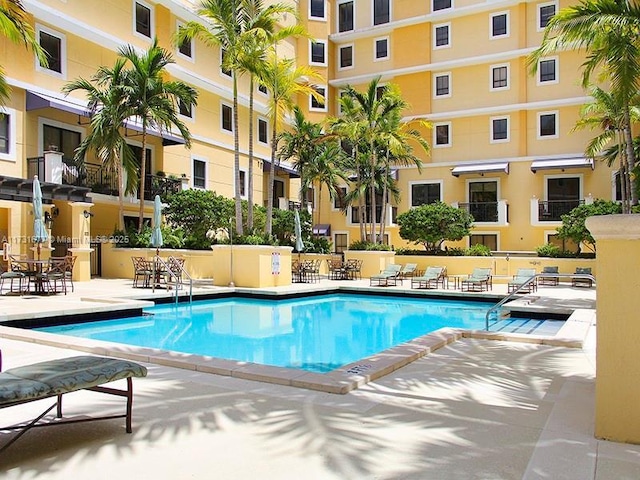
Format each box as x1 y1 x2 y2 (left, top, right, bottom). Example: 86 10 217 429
260 51 324 236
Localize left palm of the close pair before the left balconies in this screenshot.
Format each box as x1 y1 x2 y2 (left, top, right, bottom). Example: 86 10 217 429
62 58 138 230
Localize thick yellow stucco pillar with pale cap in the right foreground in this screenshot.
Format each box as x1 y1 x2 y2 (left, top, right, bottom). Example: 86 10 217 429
586 215 640 444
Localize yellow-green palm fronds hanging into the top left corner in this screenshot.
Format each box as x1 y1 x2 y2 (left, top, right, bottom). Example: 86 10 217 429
0 0 47 105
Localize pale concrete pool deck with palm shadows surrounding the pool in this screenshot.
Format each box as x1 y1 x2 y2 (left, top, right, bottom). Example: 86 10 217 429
0 280 640 480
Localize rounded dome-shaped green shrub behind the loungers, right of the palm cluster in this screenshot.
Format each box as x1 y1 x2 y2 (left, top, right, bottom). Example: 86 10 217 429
397 202 473 252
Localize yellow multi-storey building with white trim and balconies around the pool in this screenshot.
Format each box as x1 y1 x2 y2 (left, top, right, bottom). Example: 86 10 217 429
0 0 618 274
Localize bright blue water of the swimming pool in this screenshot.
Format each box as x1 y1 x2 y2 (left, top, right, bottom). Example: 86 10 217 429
38 294 561 372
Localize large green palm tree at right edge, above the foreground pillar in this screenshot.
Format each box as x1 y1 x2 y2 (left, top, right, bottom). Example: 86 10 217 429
528 0 640 205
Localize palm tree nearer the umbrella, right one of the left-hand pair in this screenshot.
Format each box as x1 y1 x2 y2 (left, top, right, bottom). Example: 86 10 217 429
118 39 198 231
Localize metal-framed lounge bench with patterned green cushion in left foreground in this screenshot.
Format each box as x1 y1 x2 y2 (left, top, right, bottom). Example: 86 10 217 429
0 353 147 452
